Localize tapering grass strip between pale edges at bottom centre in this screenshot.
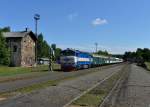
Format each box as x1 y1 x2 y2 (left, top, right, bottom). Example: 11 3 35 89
70 70 121 107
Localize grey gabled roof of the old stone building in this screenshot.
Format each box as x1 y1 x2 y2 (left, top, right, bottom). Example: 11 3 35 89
3 31 37 40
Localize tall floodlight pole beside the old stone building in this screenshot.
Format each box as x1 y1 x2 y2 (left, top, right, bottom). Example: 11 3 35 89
34 14 40 65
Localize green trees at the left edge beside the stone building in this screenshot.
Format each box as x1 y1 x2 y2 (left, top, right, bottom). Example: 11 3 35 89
0 27 10 65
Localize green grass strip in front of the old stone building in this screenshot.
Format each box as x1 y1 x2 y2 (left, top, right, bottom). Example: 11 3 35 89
0 64 60 76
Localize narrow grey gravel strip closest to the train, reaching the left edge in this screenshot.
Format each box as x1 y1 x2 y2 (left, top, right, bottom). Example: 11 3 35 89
0 65 123 93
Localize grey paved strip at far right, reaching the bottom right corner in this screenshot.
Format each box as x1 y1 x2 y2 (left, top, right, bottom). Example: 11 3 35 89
105 64 150 107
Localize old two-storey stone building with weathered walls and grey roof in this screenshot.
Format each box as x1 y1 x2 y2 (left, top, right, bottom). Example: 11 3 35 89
3 30 37 66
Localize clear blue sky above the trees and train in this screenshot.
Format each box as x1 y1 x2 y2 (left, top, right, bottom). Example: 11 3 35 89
0 0 150 54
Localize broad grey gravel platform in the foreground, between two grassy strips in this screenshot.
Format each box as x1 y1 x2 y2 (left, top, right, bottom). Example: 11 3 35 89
0 65 124 107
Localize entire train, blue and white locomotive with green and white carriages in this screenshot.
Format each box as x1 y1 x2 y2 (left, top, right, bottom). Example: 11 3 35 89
60 48 123 71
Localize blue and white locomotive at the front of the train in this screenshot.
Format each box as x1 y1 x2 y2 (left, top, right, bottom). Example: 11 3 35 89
60 49 93 70
